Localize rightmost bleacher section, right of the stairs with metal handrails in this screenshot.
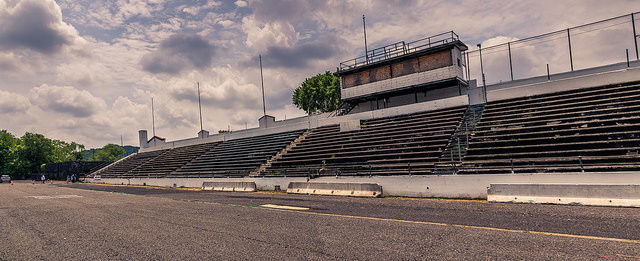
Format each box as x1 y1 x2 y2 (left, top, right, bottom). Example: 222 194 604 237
459 83 640 174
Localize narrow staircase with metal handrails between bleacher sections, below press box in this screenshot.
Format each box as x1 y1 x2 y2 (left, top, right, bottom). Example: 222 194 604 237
434 104 485 175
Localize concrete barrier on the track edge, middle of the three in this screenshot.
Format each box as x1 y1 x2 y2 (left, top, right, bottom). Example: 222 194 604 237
287 182 382 197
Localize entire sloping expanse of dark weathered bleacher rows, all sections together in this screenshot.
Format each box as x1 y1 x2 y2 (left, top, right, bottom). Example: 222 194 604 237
91 83 640 177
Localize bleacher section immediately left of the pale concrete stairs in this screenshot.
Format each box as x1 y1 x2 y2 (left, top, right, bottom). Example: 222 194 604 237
170 130 304 177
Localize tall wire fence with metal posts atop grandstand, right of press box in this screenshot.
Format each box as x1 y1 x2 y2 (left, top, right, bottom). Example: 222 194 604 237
462 12 640 85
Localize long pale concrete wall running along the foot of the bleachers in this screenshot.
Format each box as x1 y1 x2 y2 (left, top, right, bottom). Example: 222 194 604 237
87 172 640 199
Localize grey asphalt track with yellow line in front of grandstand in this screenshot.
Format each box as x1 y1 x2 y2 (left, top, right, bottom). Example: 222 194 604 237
0 182 640 260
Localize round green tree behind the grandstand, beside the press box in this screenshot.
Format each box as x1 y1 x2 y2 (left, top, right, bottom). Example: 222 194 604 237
293 71 342 114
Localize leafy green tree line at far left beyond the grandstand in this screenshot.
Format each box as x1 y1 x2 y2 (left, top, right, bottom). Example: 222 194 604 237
0 130 124 178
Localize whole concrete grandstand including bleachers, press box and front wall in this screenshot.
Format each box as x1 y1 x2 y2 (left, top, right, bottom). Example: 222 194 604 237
90 15 640 203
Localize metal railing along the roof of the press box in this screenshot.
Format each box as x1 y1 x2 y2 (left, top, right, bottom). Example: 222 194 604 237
340 31 459 70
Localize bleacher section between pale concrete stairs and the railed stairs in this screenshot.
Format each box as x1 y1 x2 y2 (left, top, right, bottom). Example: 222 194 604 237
261 107 465 177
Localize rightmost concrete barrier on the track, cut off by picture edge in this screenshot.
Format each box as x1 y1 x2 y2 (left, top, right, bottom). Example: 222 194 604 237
487 184 640 207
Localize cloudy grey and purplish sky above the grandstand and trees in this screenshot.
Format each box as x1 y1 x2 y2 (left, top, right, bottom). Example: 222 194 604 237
0 0 639 147
